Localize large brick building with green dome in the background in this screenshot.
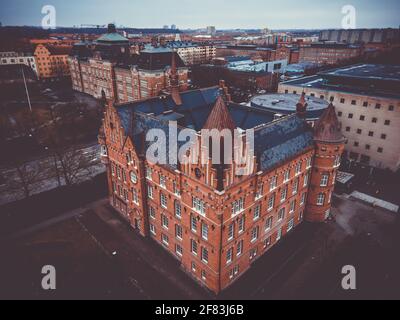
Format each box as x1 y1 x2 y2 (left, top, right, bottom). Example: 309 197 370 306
69 25 188 103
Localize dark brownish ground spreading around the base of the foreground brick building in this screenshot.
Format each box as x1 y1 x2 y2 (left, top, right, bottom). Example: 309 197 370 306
0 198 400 300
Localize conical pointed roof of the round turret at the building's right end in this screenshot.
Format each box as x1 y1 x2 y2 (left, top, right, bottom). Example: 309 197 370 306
314 103 345 143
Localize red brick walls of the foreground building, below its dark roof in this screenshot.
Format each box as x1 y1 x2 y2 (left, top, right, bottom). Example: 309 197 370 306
99 86 342 293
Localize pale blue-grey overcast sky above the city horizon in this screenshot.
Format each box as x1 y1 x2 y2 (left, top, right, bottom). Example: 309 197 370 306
0 0 400 29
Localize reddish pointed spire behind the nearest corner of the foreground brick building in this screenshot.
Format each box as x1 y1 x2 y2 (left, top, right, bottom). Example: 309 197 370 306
203 95 236 131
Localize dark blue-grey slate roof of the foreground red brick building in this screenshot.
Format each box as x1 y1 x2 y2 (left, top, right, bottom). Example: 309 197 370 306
117 87 313 170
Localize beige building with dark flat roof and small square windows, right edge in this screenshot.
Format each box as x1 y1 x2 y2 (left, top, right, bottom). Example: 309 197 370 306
278 64 400 171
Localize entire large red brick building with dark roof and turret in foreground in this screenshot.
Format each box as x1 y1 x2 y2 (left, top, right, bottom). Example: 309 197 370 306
99 84 344 293
